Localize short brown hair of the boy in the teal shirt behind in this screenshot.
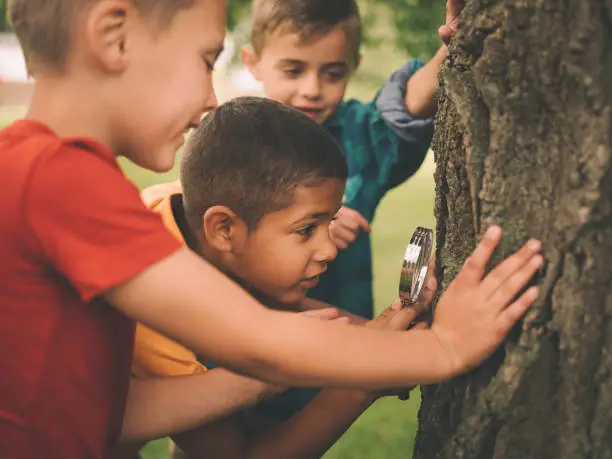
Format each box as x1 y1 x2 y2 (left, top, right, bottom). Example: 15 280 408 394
251 0 362 62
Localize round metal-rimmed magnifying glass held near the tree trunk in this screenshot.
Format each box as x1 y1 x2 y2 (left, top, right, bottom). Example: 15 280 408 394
399 226 433 307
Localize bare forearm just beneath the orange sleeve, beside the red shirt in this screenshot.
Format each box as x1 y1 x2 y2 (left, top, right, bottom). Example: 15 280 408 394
121 368 270 441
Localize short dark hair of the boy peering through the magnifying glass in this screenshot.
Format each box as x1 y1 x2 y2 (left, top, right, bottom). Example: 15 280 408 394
181 97 348 233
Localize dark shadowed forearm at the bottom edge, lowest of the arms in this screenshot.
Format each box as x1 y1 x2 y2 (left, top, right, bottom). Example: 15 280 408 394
243 389 375 459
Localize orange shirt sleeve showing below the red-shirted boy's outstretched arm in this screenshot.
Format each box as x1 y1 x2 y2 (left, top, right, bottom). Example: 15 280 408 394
132 324 206 378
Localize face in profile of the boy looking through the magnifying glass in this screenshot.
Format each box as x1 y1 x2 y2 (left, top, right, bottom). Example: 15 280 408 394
226 179 345 305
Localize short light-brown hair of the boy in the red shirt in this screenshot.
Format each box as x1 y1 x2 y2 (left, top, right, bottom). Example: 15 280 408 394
8 0 195 73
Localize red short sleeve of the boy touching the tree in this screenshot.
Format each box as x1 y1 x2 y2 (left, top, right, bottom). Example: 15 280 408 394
23 142 180 302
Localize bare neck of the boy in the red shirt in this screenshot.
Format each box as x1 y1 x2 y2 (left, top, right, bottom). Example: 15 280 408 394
26 74 113 148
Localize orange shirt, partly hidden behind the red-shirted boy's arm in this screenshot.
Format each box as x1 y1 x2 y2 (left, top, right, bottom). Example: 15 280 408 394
132 181 206 378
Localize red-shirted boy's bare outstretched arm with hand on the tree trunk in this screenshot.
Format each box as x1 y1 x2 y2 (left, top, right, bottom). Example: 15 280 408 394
106 228 542 389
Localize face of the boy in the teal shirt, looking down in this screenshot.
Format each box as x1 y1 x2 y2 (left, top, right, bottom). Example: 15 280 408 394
243 26 356 124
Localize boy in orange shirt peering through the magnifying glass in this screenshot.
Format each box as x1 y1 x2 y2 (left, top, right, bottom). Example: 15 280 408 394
117 97 435 459
